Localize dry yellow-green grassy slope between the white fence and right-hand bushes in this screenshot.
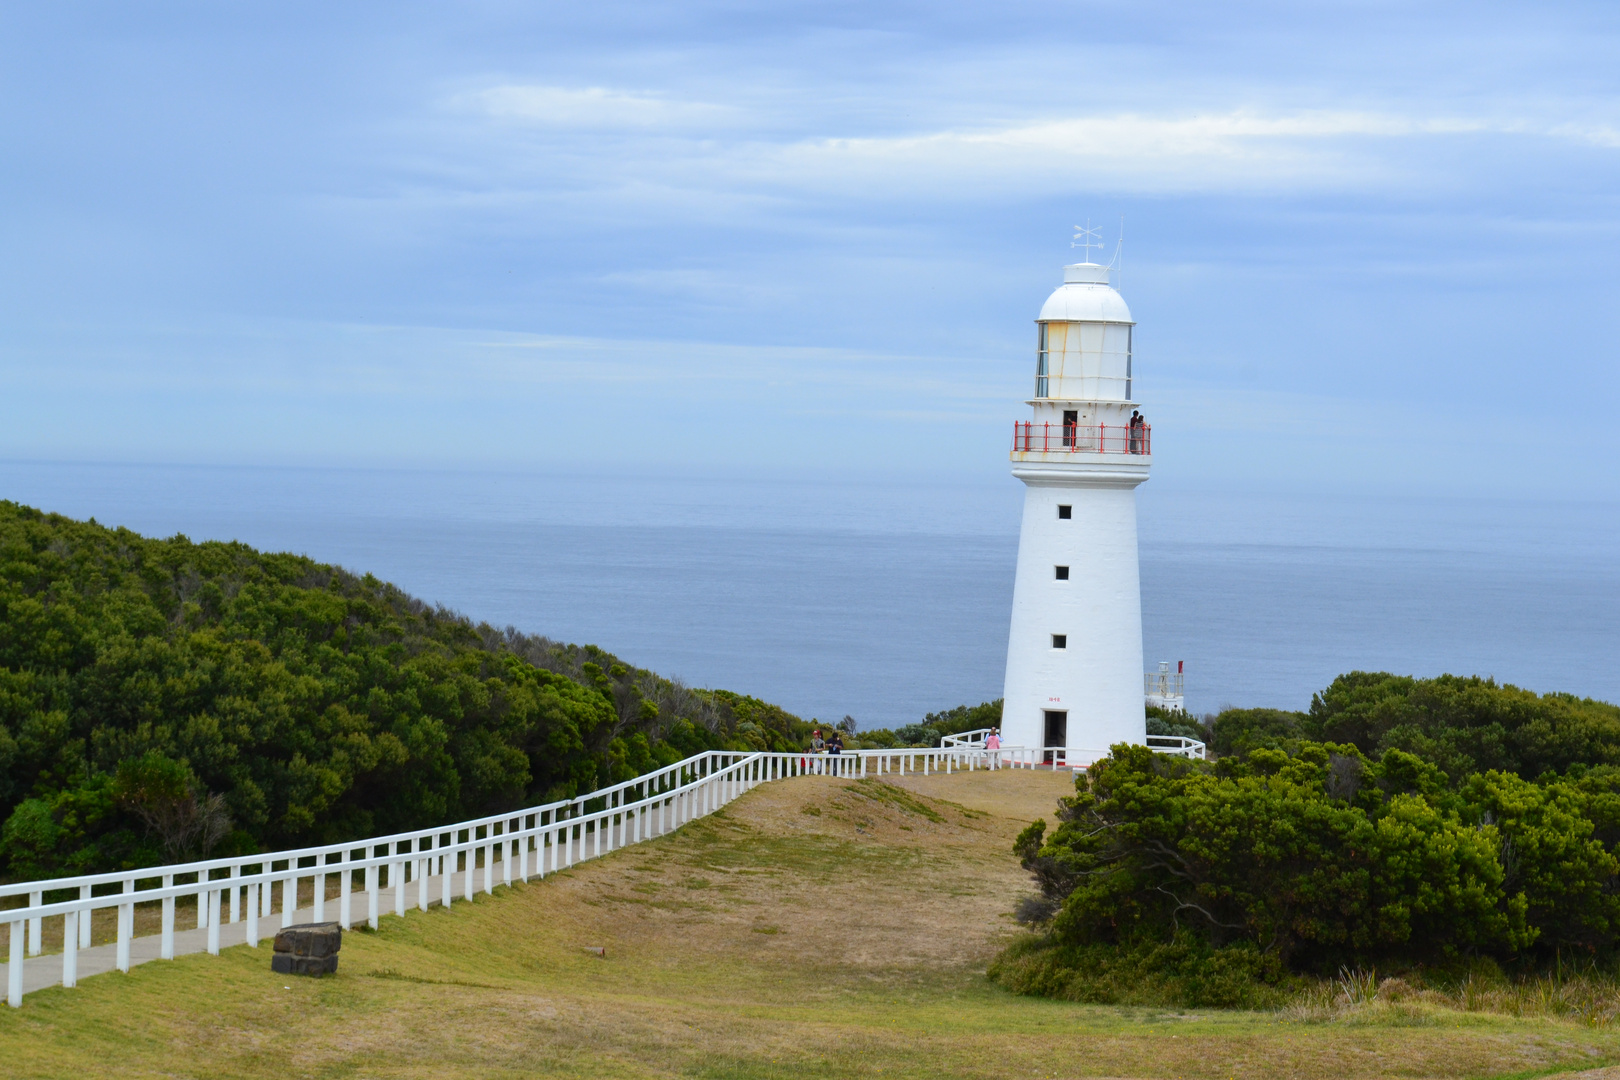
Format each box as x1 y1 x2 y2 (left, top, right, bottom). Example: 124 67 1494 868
0 772 1620 1080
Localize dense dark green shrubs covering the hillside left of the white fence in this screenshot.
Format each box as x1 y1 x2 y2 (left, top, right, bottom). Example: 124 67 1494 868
0 502 790 878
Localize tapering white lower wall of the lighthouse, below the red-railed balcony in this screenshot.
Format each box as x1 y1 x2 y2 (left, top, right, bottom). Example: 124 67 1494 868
1001 470 1147 750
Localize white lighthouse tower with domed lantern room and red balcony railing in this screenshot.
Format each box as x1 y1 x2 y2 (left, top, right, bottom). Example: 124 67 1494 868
1001 248 1153 764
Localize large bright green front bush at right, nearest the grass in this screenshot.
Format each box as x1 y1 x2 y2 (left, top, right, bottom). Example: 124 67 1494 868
1014 742 1620 972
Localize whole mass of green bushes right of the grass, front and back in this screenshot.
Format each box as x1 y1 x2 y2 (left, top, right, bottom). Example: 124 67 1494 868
995 672 1620 1004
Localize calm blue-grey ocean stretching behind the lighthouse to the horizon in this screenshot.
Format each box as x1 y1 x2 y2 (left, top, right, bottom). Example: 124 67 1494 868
0 461 1620 727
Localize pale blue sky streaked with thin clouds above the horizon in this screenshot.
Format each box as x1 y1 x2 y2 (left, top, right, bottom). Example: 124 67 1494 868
0 2 1620 499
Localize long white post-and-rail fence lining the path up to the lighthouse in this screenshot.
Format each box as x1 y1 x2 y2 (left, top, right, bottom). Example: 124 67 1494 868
0 744 1204 1007
